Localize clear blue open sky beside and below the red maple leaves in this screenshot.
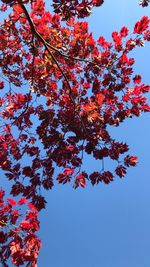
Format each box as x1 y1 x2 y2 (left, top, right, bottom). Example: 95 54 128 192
38 0 150 267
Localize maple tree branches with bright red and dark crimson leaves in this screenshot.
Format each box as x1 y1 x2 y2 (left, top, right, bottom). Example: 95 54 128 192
0 0 150 266
